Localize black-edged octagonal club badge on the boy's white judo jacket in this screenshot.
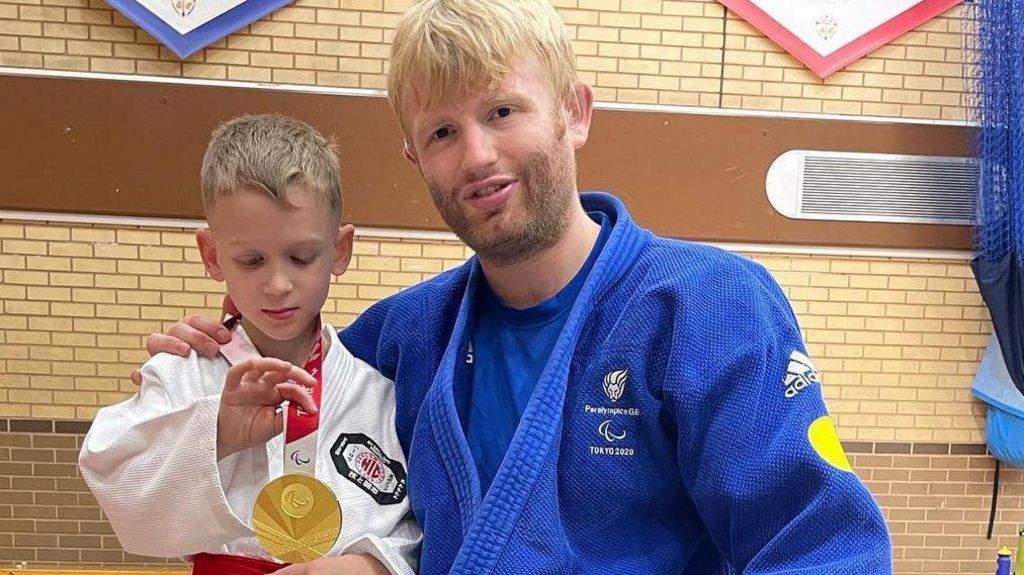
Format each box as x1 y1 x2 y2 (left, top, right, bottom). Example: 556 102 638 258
331 433 407 505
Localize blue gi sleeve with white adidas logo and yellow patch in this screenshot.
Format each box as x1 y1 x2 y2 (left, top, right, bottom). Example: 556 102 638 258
666 262 892 575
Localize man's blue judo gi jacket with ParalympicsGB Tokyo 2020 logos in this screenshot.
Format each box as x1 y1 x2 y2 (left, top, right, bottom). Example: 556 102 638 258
342 193 892 575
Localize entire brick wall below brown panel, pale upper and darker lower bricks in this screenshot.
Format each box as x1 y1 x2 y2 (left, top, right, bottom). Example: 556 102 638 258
0 220 1024 574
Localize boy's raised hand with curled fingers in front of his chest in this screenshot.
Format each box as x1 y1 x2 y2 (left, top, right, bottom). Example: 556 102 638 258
217 357 316 461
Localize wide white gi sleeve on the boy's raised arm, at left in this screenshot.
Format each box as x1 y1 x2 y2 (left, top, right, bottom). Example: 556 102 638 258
79 352 266 557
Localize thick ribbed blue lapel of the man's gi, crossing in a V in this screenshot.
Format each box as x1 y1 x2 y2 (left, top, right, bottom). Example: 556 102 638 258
427 193 650 573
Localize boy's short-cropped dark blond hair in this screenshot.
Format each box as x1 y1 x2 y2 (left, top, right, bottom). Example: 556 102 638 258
201 114 341 219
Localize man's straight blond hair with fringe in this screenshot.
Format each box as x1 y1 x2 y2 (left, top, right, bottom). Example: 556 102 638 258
387 0 577 134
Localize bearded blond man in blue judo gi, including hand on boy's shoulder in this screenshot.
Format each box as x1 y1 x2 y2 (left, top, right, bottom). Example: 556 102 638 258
142 0 891 575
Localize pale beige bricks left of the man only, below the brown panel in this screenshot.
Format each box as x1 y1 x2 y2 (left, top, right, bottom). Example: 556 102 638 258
0 220 467 419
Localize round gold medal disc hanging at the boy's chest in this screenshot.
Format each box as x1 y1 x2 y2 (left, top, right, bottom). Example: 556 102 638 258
253 474 341 563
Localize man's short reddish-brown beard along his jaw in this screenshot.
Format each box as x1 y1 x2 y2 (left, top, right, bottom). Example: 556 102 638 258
429 140 578 265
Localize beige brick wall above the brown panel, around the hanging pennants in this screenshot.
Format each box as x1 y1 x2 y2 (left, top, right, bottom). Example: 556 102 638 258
0 0 964 120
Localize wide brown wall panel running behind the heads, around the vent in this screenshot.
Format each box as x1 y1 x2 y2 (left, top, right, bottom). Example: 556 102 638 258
0 76 971 249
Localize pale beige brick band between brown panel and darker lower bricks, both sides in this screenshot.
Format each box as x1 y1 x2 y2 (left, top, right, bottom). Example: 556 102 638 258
0 216 991 443
